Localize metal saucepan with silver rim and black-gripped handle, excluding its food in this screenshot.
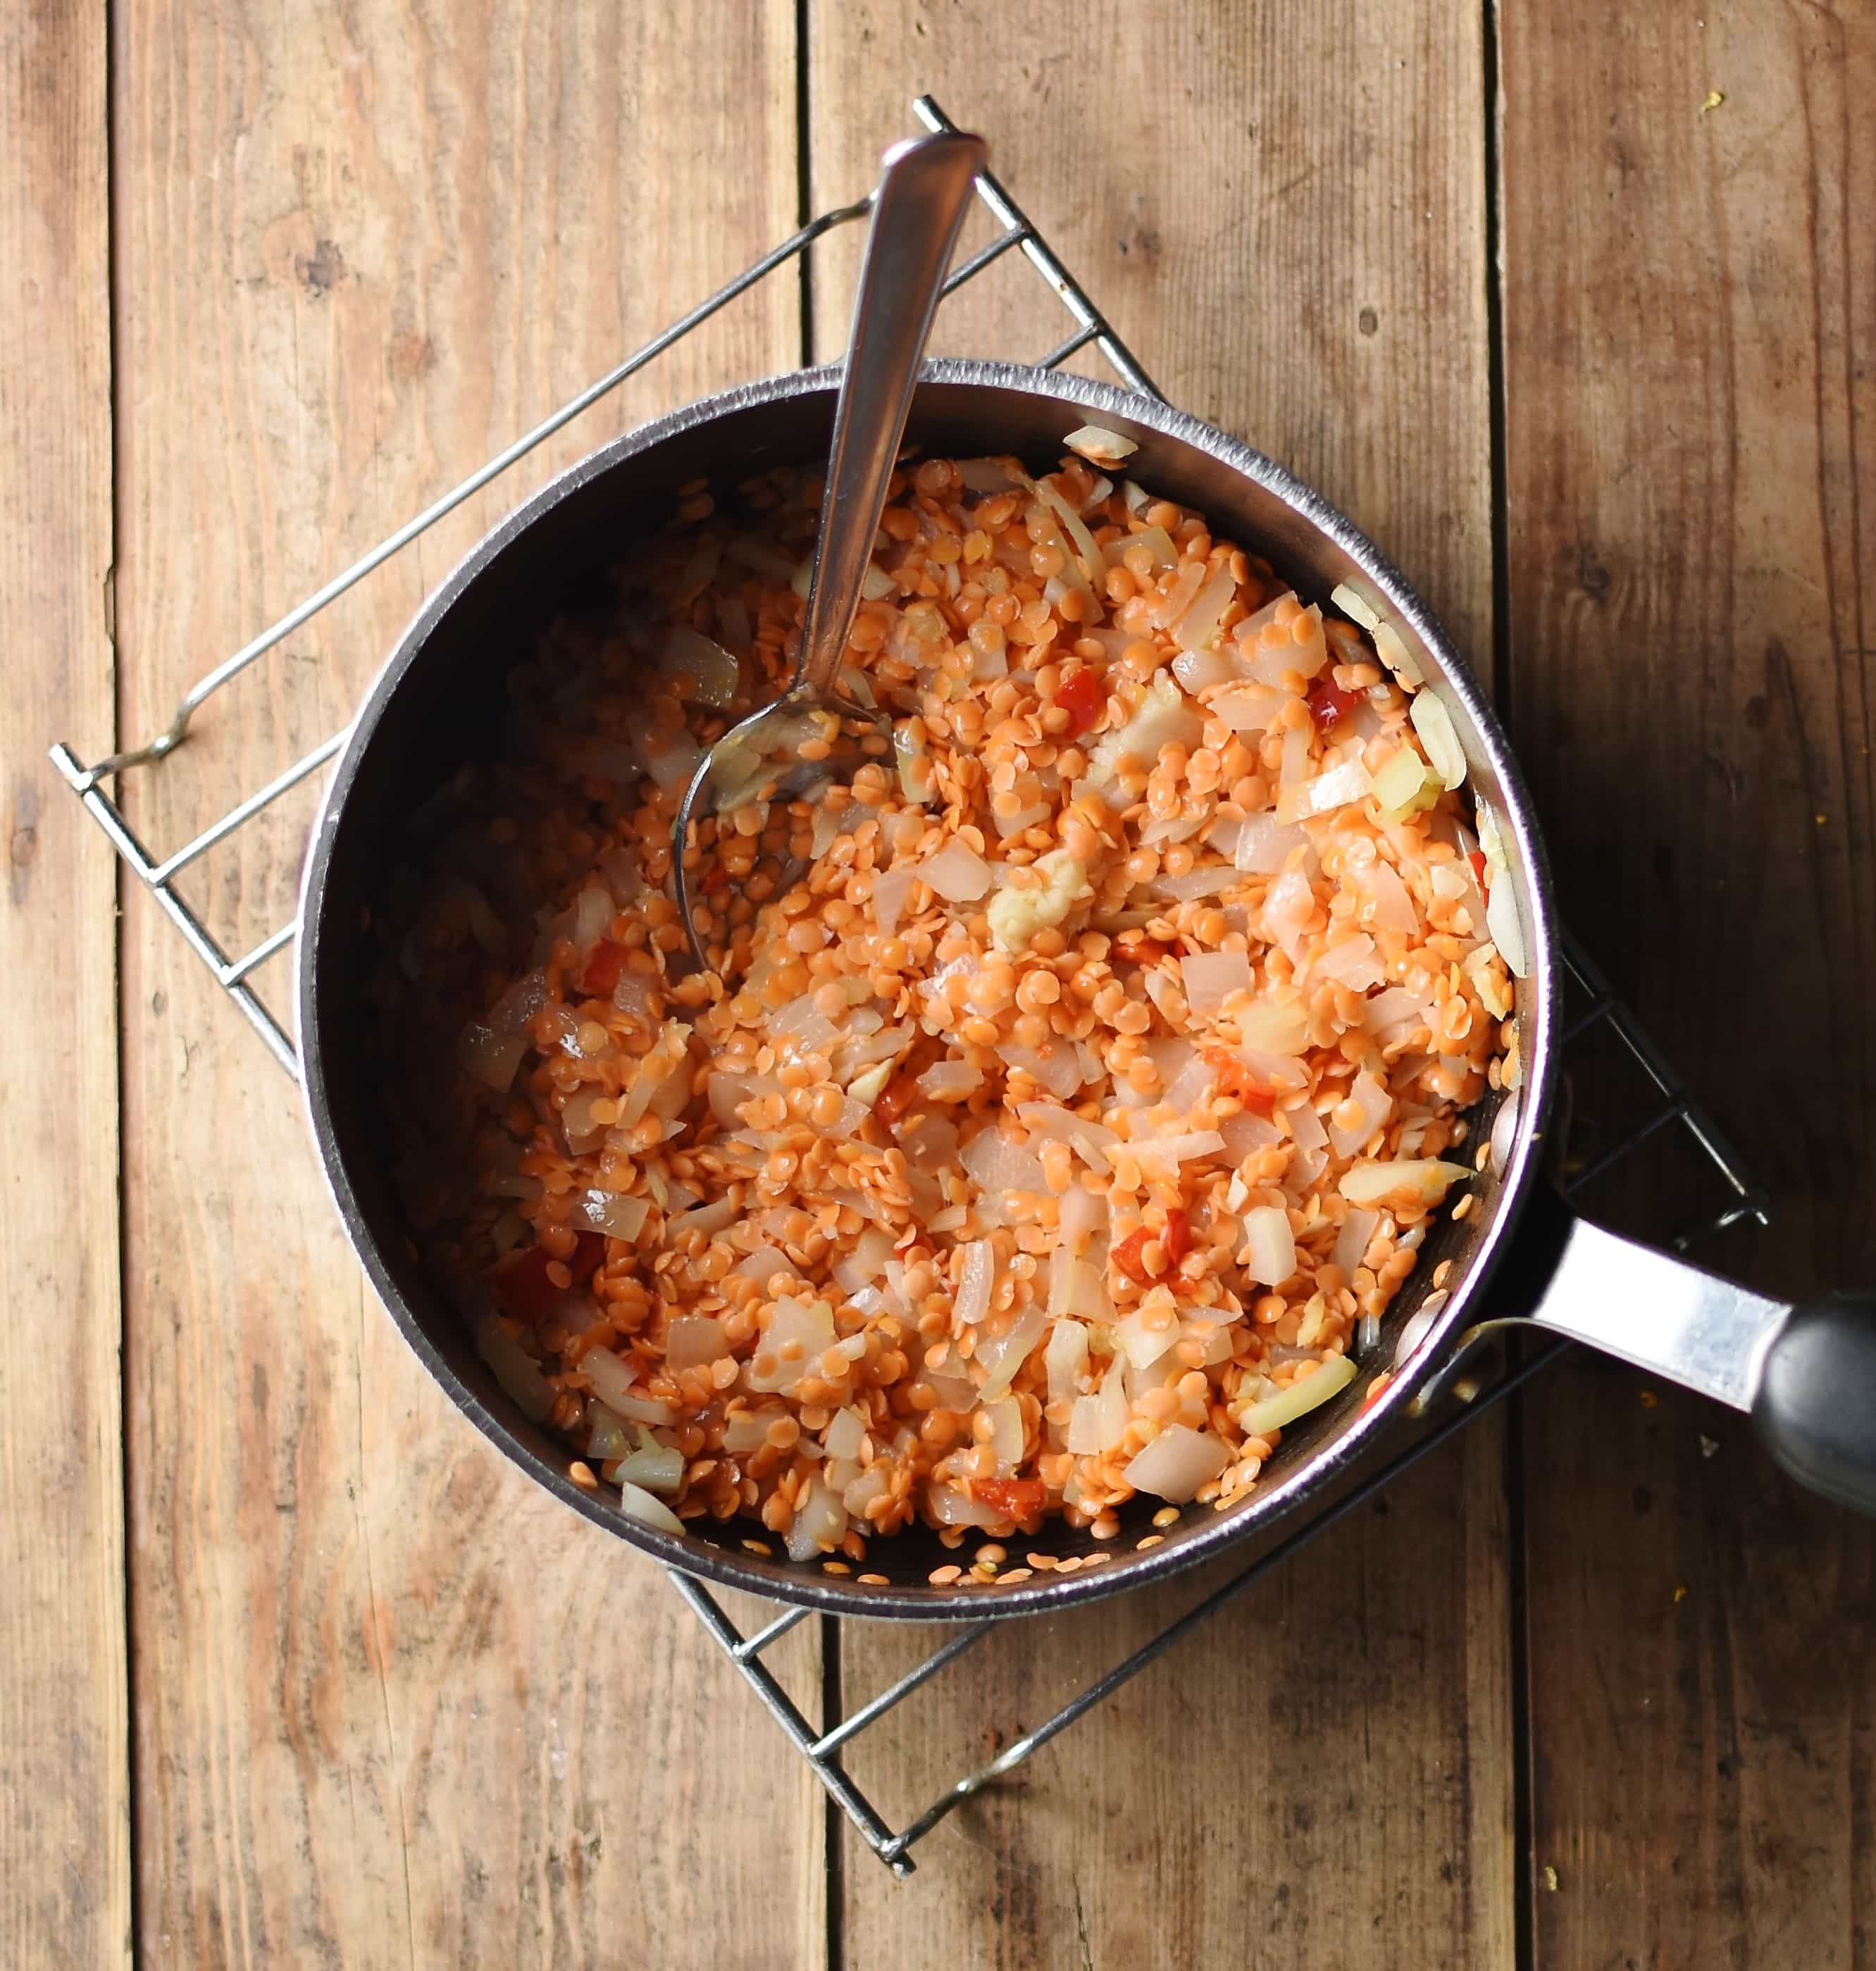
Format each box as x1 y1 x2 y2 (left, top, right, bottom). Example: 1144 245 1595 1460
297 361 1876 1620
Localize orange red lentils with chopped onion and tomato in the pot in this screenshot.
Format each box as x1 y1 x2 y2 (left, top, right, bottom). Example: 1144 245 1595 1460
378 430 1521 1565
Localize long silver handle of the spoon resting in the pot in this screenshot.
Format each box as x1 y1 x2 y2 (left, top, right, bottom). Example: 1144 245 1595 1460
800 130 986 692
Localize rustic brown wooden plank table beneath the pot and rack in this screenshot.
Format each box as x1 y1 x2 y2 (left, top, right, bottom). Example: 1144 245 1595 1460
0 0 1876 1971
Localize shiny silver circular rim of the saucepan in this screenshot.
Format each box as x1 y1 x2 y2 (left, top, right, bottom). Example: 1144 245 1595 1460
296 356 1563 1622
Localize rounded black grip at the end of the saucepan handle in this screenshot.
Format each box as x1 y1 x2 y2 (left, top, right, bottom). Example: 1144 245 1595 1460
1752 1293 1876 1514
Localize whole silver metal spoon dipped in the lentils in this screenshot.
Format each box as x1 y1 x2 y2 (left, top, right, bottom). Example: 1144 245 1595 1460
672 130 987 968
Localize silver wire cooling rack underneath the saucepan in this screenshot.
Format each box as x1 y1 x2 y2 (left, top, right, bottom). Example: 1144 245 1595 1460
51 97 1768 1877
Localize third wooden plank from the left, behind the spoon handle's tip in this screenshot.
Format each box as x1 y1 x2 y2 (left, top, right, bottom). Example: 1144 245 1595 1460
810 4 1513 1971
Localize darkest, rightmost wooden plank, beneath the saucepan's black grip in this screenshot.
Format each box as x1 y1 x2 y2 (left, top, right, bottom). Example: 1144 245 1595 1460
1500 6 1876 1967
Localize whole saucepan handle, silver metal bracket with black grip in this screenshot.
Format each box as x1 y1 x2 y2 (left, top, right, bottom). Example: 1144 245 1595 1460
1443 1186 1876 1514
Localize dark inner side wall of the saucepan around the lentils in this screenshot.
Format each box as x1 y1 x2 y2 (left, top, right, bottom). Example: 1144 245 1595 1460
304 383 1529 1615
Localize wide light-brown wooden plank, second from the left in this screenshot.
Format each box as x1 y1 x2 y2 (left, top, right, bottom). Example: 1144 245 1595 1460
114 0 824 1967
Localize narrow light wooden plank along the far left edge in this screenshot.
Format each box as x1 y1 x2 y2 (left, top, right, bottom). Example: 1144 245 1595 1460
0 6 130 1967
